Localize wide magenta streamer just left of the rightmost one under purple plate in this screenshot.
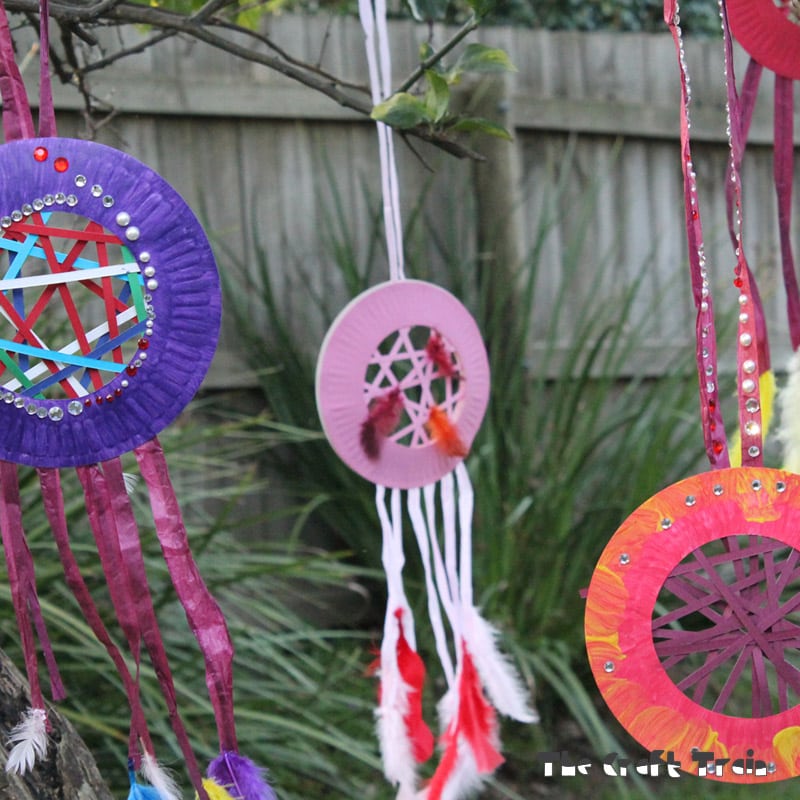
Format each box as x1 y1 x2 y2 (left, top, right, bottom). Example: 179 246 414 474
77 459 208 800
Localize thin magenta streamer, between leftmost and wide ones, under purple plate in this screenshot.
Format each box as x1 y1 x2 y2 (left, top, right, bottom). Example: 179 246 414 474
37 468 154 769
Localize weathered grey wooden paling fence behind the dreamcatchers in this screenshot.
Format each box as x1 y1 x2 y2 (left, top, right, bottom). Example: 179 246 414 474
21 16 800 387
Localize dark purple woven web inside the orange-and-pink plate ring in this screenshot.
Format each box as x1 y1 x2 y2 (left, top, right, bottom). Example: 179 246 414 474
653 536 800 717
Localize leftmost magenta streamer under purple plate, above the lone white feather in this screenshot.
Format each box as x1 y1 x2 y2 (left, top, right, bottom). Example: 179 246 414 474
0 461 66 709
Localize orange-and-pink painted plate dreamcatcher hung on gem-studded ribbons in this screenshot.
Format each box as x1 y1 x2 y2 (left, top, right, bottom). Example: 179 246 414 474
585 0 800 783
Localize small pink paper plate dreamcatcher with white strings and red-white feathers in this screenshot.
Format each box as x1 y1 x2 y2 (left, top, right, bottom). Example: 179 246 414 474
316 0 535 800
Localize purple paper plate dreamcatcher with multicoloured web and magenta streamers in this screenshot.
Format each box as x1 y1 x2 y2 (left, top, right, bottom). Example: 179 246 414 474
0 4 274 800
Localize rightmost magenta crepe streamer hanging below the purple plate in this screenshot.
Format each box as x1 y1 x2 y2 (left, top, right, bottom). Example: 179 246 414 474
134 439 238 752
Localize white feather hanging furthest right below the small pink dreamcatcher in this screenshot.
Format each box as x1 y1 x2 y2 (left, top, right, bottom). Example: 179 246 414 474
464 607 539 722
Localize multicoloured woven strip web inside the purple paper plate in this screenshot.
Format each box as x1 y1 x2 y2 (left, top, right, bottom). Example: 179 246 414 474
0 210 147 399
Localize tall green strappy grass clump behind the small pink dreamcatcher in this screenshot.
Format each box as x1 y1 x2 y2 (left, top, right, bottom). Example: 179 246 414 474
217 141 702 796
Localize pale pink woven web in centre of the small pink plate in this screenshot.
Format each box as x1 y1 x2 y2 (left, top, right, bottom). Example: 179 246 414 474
364 325 464 447
